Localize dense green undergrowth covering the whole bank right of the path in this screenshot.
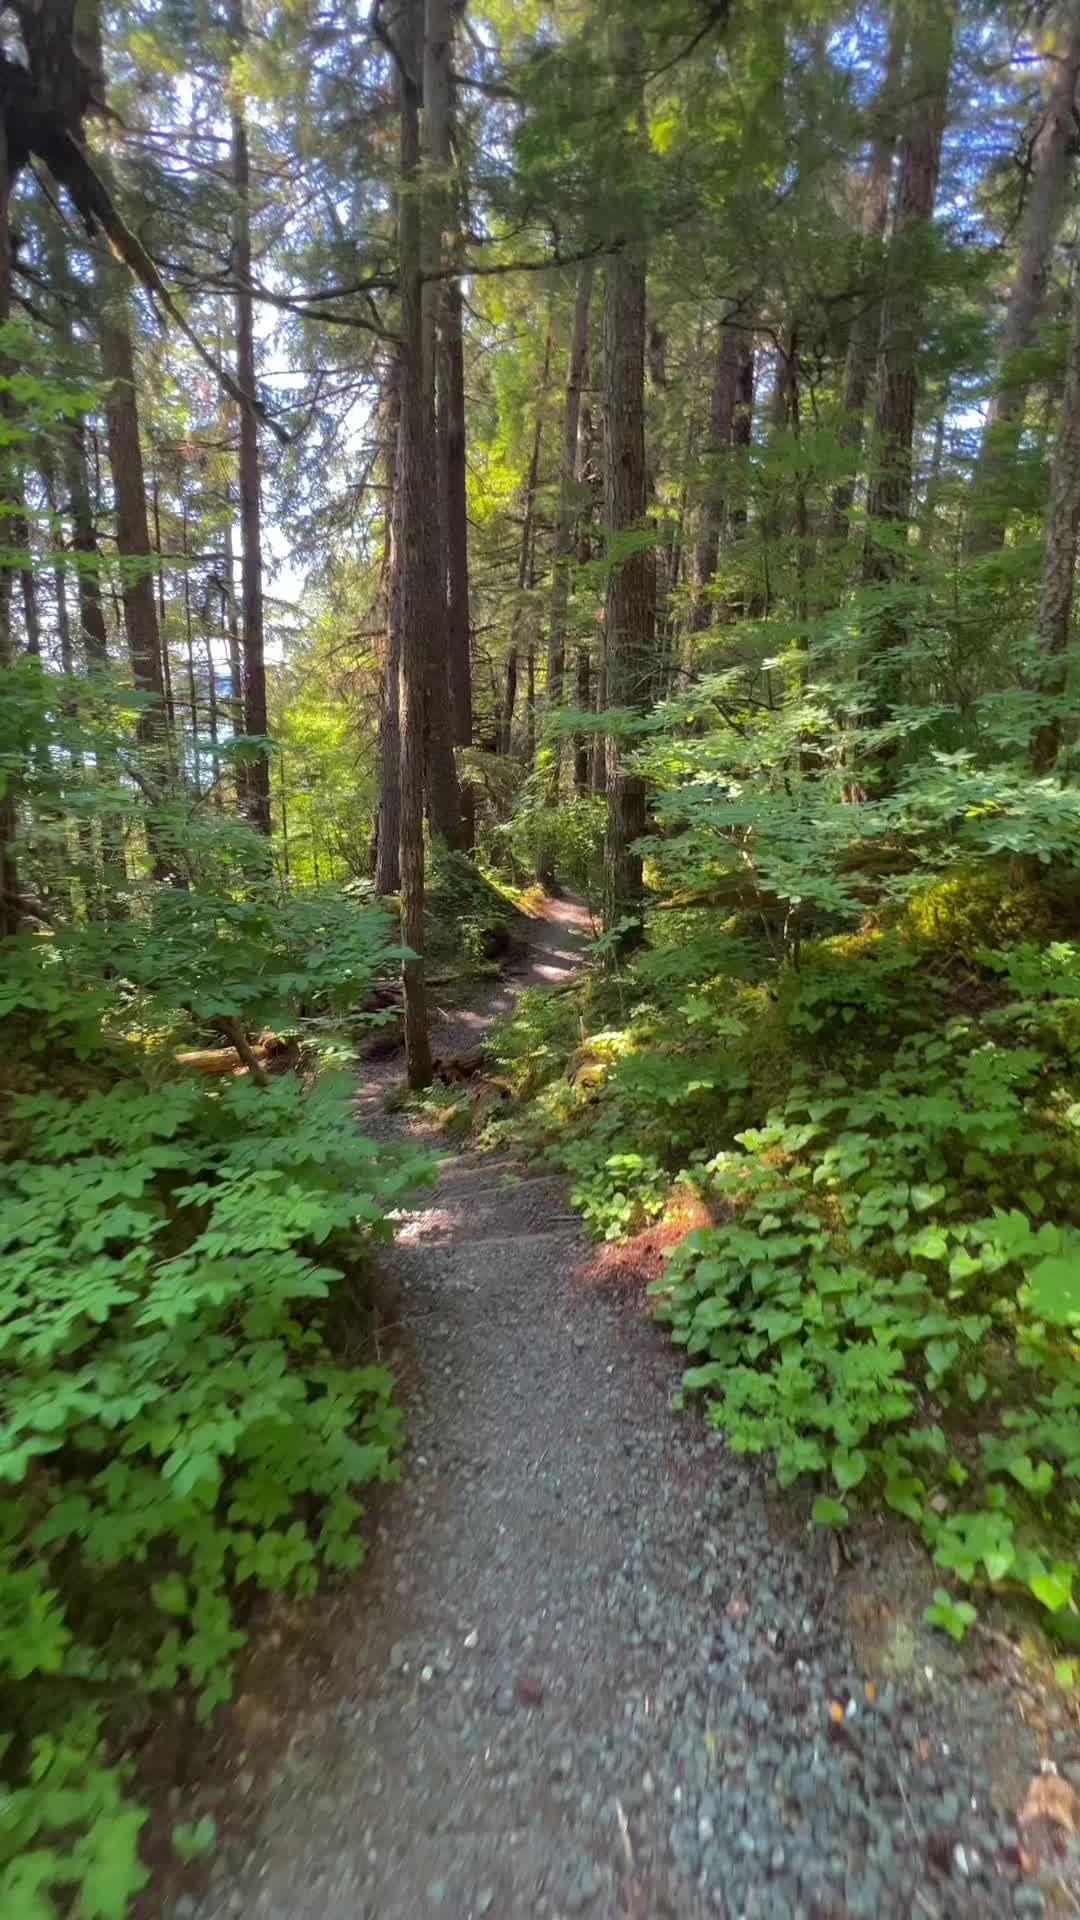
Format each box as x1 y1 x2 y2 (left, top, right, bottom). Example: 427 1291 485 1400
488 810 1080 1676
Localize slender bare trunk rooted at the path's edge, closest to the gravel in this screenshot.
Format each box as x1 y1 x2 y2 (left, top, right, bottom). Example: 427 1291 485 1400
394 0 436 1087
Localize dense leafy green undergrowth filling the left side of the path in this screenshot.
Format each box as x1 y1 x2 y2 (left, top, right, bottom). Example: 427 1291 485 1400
0 670 434 1920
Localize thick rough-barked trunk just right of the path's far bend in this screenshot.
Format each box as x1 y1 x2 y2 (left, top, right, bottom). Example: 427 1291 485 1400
603 222 655 936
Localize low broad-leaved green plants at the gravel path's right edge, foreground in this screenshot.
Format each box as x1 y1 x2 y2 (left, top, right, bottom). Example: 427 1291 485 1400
657 1006 1080 1636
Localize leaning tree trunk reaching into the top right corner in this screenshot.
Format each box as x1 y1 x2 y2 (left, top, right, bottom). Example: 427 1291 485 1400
965 0 1080 555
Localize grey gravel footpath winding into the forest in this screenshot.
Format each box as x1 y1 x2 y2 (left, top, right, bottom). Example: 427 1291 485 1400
174 900 1080 1920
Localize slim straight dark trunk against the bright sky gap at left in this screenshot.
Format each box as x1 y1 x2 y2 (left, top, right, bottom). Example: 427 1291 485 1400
229 0 271 833
